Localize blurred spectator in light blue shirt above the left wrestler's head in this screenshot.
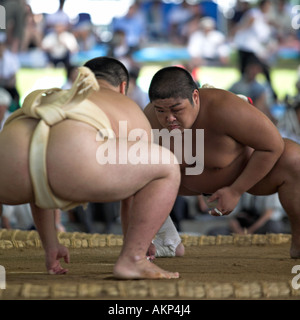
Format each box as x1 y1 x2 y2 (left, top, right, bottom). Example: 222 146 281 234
112 3 146 52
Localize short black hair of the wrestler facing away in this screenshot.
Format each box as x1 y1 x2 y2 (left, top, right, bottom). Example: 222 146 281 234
84 57 129 92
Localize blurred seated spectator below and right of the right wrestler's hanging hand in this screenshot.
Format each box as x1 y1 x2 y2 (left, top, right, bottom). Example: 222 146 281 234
229 193 287 234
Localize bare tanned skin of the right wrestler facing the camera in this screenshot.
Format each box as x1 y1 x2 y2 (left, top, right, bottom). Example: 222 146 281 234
144 88 300 257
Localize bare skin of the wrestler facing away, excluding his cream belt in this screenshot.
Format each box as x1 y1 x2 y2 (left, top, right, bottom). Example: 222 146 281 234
0 69 180 279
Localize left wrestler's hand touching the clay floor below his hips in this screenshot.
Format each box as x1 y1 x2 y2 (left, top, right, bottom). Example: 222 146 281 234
46 244 70 274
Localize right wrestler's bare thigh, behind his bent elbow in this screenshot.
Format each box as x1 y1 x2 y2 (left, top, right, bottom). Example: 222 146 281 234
249 139 300 195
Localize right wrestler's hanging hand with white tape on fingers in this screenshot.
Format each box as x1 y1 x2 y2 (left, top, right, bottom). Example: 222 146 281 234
208 187 241 216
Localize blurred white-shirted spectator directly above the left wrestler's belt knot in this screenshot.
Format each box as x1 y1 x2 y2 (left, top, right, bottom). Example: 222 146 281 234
42 24 78 68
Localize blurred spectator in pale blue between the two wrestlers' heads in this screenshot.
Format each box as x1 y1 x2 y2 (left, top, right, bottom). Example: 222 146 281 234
127 68 149 110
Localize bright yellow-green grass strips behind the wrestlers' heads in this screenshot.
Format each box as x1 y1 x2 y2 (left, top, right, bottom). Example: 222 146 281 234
17 64 298 101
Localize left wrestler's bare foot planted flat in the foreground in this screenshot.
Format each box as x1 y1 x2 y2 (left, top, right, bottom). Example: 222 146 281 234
114 257 179 279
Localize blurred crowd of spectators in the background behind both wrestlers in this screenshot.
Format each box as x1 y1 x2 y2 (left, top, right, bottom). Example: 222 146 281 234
0 0 300 233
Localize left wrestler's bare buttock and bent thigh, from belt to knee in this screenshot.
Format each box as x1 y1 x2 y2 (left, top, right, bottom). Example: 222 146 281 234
47 127 179 202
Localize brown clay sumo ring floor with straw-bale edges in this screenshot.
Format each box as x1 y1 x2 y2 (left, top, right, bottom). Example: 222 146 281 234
0 229 300 300
